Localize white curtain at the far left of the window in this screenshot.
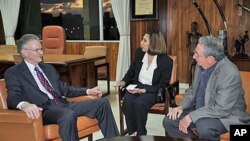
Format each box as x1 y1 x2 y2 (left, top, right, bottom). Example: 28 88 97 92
0 0 21 45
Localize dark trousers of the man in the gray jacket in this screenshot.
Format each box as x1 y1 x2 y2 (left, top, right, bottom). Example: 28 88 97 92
163 112 227 141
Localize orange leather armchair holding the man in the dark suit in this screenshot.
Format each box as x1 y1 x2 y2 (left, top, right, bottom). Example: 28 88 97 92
0 79 100 141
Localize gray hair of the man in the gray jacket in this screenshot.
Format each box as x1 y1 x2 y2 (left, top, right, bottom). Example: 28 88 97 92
198 36 225 61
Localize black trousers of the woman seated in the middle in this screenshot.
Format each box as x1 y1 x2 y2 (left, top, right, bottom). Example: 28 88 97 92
123 92 156 135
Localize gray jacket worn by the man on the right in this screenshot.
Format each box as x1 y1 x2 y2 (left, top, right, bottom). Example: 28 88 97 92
180 57 250 131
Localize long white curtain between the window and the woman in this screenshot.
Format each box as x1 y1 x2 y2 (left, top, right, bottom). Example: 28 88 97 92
111 0 130 82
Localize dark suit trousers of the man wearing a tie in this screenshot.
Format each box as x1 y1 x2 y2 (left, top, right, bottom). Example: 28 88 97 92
42 98 119 141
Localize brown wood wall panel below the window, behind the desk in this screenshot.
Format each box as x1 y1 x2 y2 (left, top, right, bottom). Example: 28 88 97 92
65 41 119 81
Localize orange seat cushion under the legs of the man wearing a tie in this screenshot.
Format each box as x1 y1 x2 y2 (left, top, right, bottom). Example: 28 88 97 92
44 116 98 140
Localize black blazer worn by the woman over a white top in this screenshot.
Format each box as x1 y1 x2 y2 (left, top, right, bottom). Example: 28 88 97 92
122 48 173 93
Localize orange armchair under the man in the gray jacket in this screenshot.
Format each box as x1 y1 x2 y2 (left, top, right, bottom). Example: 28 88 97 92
175 71 250 141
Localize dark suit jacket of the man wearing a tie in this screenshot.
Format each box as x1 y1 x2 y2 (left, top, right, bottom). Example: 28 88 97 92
4 61 86 109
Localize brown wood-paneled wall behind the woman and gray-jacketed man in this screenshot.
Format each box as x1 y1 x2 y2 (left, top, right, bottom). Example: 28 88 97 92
131 0 250 83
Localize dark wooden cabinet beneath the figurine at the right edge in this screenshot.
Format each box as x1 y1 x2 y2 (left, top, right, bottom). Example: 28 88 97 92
231 58 250 71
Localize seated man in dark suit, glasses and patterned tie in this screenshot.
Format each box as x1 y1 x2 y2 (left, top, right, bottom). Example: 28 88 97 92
4 34 119 141
